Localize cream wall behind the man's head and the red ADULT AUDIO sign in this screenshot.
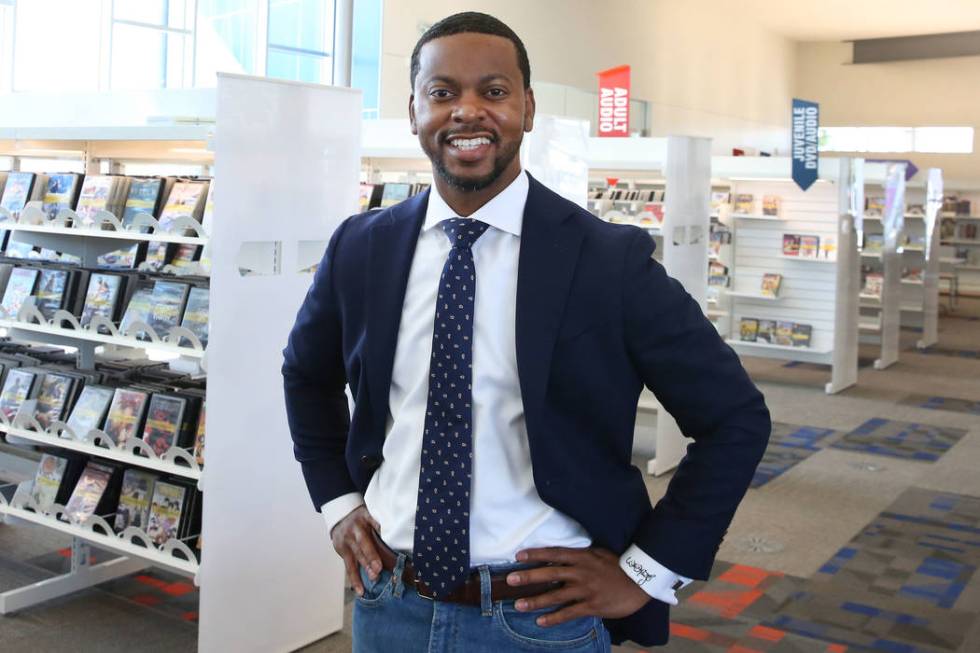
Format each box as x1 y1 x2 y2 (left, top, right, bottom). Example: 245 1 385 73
381 0 796 152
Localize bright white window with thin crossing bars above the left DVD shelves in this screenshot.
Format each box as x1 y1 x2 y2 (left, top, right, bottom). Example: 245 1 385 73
109 0 195 89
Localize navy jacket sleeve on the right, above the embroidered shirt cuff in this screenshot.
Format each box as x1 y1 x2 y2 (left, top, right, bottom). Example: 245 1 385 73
623 231 771 580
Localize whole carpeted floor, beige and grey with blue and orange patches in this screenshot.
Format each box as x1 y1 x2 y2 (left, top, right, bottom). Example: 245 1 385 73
0 302 980 653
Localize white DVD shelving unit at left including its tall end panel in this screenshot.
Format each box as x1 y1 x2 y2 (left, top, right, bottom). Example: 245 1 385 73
0 75 361 652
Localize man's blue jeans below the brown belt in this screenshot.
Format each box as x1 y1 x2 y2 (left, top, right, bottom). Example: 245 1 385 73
353 554 610 653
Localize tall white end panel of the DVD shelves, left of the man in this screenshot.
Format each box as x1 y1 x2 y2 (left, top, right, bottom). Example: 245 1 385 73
199 74 361 653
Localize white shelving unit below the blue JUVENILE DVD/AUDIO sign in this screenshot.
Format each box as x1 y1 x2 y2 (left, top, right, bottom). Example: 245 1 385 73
712 157 863 393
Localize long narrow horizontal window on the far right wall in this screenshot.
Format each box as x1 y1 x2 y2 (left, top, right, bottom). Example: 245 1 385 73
820 127 973 154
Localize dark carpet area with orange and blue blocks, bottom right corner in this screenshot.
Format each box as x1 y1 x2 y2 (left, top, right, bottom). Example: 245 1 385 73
628 488 980 653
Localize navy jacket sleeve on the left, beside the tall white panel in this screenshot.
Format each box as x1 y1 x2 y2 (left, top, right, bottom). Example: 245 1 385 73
282 221 357 512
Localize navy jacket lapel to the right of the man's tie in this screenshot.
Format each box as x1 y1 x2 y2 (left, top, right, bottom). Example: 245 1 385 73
516 175 584 412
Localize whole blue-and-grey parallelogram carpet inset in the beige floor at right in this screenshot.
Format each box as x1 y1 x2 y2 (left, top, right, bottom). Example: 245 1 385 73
831 417 966 462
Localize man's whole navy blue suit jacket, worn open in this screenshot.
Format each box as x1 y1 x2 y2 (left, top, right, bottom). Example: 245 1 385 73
283 174 770 645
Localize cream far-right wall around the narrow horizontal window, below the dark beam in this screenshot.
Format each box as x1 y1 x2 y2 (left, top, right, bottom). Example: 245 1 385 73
796 43 980 191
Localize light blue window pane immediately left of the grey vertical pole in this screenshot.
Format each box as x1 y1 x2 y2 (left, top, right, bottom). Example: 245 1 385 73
265 0 334 84
